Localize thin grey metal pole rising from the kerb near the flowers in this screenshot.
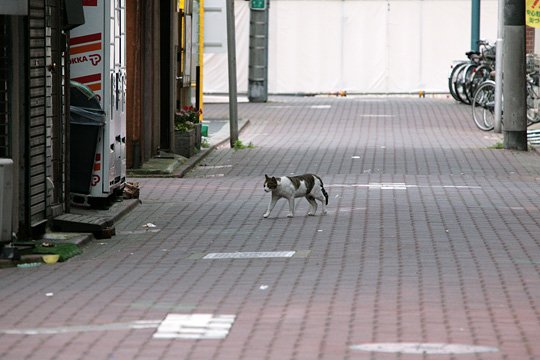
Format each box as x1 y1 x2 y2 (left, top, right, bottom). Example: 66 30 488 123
227 0 238 148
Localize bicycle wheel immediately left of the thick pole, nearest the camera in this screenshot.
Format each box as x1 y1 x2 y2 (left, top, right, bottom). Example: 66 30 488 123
472 80 495 131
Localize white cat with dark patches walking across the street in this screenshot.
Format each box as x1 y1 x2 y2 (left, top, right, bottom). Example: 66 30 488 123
263 174 328 218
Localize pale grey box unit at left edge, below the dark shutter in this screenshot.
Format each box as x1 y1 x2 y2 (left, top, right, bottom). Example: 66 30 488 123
0 159 13 242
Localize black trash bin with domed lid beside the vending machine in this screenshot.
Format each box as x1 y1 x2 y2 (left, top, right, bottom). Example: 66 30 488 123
69 81 105 195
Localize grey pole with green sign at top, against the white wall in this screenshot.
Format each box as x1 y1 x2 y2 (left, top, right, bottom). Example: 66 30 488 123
248 0 269 102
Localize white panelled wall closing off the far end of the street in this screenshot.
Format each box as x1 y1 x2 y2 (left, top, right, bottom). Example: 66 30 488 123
204 0 497 94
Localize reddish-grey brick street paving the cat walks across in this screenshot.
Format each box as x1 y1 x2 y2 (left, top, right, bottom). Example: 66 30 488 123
0 97 540 360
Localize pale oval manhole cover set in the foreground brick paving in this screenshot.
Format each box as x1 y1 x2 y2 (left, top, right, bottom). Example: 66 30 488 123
351 343 499 355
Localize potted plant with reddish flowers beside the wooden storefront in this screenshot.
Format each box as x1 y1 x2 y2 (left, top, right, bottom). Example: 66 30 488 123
174 106 201 158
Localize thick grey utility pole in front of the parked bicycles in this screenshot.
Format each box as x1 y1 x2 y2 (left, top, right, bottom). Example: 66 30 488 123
503 0 527 151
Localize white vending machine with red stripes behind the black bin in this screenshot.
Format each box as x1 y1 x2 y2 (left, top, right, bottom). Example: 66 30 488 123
69 0 126 205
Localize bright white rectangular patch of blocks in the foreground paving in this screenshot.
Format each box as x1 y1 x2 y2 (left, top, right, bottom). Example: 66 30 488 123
153 314 235 340
